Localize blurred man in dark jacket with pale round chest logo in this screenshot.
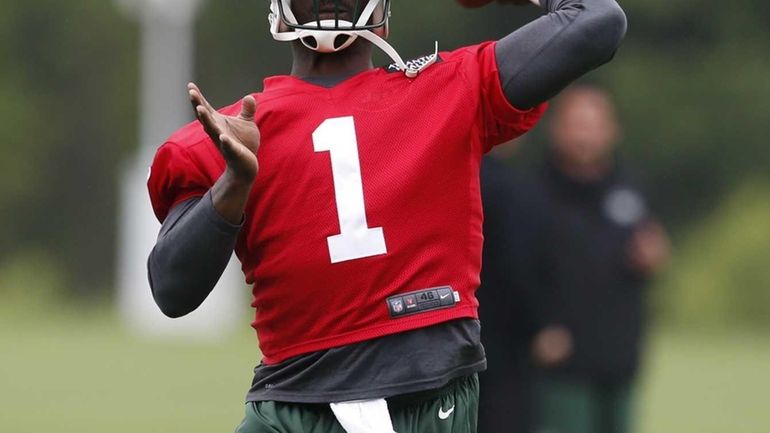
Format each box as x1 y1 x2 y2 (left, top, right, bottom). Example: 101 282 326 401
528 85 669 433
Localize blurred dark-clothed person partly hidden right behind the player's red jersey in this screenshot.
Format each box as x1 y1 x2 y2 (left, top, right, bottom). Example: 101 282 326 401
477 139 547 433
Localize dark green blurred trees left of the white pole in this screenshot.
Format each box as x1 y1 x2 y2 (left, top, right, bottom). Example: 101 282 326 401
0 0 137 292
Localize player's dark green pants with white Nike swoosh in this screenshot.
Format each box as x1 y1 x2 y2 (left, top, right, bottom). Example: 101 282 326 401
235 374 479 433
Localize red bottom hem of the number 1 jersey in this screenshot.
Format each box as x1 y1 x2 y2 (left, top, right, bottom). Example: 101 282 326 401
262 305 479 365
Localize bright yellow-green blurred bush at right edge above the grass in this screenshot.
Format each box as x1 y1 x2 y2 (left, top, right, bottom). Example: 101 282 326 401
655 179 770 329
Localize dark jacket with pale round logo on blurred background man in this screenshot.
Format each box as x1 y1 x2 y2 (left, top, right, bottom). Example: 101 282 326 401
536 157 650 380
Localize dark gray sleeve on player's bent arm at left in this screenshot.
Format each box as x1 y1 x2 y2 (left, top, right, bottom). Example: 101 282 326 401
147 192 242 317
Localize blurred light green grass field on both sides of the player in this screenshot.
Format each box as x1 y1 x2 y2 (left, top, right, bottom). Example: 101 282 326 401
0 306 770 433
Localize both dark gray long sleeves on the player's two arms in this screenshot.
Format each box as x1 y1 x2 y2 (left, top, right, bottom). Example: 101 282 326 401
148 0 626 317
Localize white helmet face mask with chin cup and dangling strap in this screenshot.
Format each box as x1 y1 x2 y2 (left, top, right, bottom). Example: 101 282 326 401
269 0 438 78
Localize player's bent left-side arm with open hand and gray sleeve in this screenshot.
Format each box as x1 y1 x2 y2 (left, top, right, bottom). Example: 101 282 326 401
147 84 260 317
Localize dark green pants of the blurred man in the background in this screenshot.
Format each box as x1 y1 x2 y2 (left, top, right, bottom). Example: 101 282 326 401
537 378 632 433
